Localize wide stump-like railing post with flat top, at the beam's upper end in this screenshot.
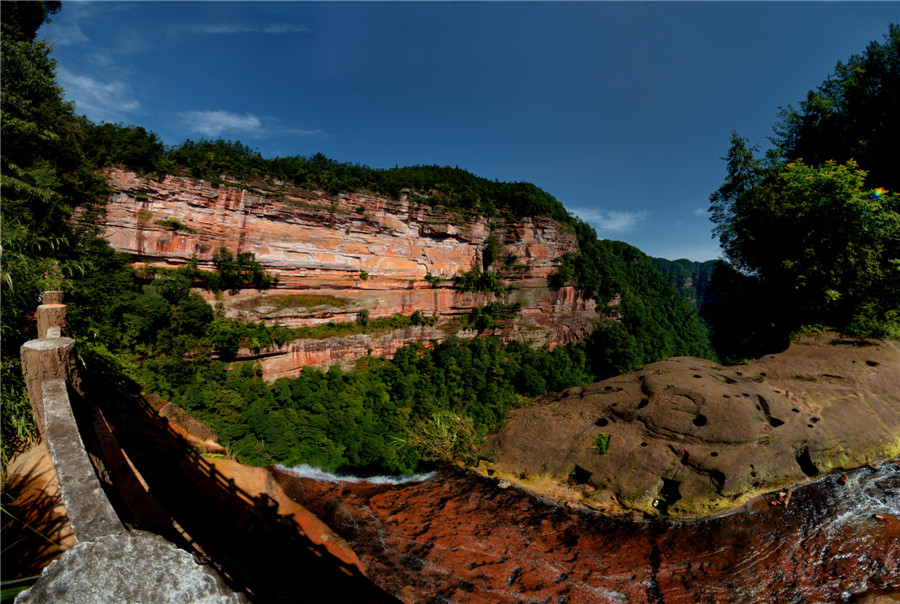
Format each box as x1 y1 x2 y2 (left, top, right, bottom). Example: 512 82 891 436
19 338 83 435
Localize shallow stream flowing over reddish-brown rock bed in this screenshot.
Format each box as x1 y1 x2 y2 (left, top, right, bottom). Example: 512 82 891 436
279 462 900 604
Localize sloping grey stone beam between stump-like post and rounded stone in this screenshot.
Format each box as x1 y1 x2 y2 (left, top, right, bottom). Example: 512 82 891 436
43 380 125 543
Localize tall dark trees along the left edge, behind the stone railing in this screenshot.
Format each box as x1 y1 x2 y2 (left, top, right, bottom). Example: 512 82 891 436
0 2 103 460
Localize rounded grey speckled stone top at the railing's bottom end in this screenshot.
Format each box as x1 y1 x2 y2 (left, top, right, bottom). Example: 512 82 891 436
16 531 247 604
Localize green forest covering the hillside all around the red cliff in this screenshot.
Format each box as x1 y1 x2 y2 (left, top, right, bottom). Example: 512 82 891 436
2 3 714 471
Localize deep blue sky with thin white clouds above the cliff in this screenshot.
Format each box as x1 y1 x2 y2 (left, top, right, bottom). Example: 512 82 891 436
39 2 900 260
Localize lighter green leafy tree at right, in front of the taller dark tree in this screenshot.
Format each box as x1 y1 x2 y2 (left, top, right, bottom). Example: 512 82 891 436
712 137 900 344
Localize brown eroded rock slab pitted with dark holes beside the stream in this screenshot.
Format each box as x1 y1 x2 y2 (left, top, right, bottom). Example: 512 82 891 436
482 334 900 518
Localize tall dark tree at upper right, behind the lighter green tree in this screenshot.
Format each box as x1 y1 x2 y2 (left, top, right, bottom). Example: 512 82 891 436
774 24 900 191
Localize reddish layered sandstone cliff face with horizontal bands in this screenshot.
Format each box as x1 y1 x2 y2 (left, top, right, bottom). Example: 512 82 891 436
103 170 599 376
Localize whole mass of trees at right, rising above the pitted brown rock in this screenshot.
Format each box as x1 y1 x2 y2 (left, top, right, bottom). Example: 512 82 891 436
705 25 900 356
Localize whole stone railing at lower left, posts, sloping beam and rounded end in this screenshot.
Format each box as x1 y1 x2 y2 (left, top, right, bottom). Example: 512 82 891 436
16 292 246 603
